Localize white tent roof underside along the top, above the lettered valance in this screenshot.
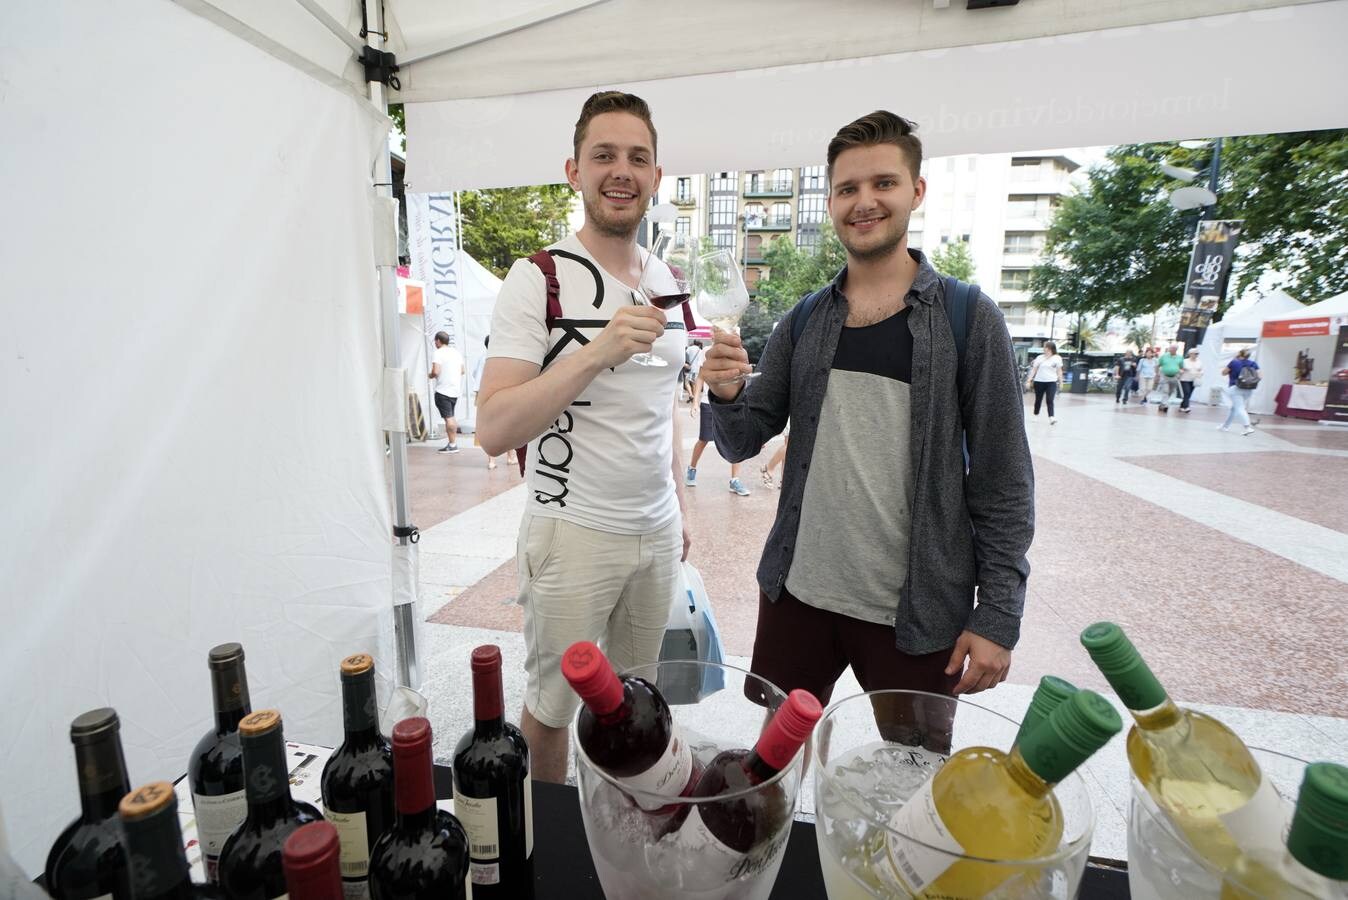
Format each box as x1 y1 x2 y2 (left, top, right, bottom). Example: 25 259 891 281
175 0 1314 101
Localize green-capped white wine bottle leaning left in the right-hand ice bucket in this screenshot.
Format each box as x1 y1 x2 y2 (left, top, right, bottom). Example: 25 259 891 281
1081 622 1285 870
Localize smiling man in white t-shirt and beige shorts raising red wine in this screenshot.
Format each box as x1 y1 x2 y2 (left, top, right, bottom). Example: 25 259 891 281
477 92 687 781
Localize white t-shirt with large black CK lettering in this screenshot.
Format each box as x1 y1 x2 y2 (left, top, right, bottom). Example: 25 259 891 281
487 234 687 535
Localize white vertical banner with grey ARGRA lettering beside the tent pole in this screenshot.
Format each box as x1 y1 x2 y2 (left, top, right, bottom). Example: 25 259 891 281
407 193 466 431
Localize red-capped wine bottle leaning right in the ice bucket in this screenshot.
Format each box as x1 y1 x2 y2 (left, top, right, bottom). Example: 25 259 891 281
679 690 824 878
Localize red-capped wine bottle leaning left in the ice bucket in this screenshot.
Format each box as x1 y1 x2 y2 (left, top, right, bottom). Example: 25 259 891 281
562 641 693 811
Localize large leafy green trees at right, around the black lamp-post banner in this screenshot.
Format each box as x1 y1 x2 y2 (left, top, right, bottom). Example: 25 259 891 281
1030 129 1348 318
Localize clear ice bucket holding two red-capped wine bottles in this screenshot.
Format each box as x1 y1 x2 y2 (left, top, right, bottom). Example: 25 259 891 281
573 660 805 900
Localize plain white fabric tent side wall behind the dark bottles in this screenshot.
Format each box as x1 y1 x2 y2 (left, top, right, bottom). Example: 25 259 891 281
0 0 394 872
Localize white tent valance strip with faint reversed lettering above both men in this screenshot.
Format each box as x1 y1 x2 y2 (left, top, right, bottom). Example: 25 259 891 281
407 1 1348 191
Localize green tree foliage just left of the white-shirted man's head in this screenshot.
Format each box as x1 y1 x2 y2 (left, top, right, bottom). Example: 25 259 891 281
458 185 573 278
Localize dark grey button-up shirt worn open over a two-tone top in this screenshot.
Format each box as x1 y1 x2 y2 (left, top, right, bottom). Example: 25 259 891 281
712 251 1034 655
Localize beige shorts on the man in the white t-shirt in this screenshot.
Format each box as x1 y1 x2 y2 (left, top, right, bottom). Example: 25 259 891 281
515 516 683 728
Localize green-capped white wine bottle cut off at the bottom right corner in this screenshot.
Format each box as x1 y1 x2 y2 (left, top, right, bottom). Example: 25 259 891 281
1221 763 1348 900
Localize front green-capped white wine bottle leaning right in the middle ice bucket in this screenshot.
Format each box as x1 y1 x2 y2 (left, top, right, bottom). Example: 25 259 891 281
888 691 1123 899
